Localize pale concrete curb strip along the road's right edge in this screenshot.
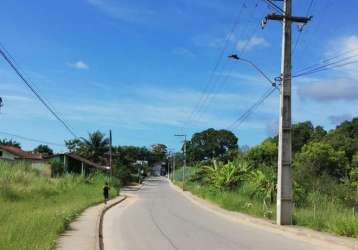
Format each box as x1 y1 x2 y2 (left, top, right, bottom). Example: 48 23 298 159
169 181 358 250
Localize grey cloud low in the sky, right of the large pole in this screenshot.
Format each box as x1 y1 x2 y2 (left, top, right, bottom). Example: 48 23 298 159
297 79 358 101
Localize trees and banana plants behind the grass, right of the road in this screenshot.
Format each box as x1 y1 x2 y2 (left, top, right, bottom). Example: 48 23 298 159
178 118 358 218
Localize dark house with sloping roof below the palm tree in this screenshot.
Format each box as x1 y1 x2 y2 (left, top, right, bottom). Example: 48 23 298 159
49 153 109 174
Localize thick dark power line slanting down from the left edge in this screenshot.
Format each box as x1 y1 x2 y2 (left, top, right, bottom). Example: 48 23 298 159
0 45 78 138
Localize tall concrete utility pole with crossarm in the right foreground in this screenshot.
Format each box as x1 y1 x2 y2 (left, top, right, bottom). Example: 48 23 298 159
263 0 311 225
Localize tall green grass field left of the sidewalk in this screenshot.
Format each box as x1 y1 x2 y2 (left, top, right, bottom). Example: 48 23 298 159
0 162 115 250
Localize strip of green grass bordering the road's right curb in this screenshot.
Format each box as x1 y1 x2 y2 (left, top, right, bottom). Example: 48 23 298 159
174 169 358 237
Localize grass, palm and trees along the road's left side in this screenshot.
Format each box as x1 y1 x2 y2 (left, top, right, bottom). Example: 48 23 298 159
0 131 167 250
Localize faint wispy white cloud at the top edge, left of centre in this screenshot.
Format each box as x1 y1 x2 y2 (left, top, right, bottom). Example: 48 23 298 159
87 0 154 23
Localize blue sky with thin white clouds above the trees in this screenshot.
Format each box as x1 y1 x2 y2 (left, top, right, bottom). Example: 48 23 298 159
0 0 358 150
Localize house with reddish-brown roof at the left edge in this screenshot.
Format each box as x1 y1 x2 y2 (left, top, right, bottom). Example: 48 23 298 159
0 145 47 169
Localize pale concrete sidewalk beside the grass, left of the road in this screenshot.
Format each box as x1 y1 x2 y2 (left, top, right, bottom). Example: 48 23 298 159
55 195 125 250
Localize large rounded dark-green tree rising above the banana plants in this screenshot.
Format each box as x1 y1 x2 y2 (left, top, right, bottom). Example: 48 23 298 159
187 128 238 161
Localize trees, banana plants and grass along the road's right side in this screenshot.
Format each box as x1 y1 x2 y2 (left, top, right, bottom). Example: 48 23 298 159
174 118 358 237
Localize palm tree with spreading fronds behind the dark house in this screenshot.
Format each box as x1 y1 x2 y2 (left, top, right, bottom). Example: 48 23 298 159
81 130 109 163
